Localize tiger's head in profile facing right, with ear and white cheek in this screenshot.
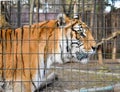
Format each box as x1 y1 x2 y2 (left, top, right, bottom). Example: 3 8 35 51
58 15 96 64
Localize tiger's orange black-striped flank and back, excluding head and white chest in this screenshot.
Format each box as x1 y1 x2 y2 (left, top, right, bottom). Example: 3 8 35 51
0 20 63 89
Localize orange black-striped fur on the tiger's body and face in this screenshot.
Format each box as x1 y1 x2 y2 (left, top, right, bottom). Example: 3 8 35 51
0 16 95 92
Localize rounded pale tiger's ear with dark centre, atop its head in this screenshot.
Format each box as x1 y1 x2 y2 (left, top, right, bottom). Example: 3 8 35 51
57 13 66 26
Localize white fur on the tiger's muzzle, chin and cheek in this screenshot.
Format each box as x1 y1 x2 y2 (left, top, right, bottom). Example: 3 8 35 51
71 32 95 64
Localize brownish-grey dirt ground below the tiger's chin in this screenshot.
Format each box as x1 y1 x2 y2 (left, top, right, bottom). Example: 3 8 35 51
40 60 120 92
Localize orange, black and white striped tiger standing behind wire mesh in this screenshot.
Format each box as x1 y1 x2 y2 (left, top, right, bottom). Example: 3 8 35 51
0 14 96 92
